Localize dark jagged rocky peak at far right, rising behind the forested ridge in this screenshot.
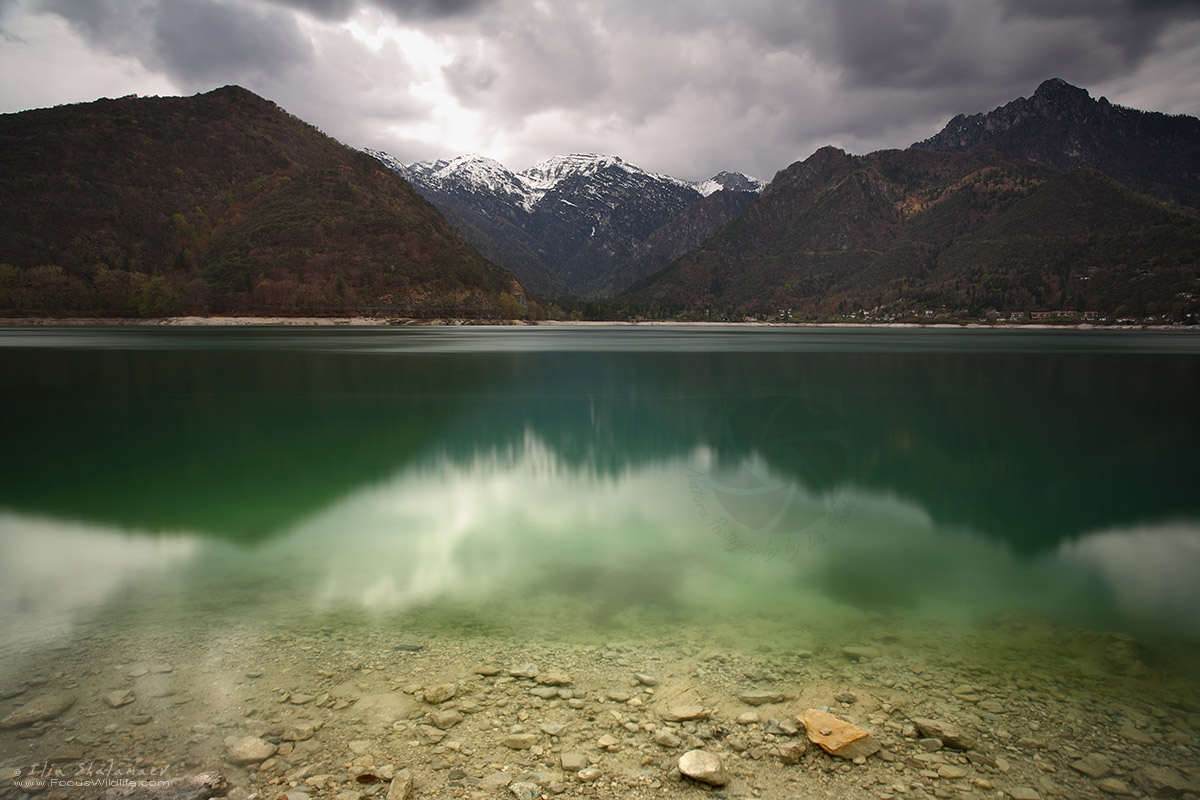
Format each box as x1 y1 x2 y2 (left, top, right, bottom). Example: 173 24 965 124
913 78 1200 207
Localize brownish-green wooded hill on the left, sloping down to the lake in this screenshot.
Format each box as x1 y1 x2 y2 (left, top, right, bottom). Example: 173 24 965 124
0 86 539 318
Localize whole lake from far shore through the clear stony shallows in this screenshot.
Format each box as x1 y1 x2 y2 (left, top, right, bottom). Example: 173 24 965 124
0 326 1200 800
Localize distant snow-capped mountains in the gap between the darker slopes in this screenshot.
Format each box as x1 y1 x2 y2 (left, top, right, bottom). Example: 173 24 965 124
367 150 763 299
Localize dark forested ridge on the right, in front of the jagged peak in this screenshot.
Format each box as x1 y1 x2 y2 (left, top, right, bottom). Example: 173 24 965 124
616 148 1200 321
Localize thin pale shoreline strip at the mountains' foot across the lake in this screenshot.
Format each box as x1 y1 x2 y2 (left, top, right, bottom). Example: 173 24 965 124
0 317 1200 331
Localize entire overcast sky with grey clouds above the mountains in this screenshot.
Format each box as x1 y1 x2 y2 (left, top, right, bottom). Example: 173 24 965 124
0 0 1200 179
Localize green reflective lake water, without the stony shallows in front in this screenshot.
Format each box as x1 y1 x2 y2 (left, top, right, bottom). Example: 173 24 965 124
0 327 1200 682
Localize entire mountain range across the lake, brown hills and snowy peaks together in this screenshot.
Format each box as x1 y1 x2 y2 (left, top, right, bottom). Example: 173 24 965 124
0 79 1200 323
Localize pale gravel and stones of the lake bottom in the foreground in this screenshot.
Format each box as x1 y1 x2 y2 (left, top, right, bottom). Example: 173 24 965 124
0 615 1200 800
